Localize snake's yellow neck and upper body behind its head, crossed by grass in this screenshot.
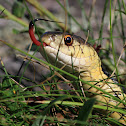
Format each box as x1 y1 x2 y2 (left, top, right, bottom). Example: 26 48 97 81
80 61 125 103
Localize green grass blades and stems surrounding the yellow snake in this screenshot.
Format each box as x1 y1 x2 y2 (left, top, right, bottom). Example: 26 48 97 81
0 0 126 126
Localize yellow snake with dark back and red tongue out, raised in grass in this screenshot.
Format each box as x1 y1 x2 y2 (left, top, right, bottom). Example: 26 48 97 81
29 18 126 125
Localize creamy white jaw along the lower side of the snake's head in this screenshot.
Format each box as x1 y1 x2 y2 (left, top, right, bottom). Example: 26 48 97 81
40 44 85 71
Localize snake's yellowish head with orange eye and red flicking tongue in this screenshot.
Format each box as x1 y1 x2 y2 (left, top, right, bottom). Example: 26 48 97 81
29 19 99 70
